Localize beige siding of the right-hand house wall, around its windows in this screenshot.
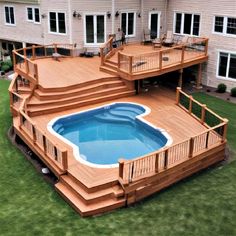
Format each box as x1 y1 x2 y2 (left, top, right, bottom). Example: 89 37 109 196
167 0 236 91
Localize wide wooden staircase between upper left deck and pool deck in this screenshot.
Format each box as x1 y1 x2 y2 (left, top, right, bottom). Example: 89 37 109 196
27 76 135 116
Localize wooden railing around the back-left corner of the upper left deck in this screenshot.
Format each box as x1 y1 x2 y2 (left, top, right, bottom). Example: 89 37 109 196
13 44 74 84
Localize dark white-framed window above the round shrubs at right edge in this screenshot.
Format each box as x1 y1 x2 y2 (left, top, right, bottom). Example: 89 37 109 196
218 52 236 79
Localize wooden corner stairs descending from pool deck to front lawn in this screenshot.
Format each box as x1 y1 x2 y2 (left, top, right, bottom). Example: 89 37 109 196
55 173 126 216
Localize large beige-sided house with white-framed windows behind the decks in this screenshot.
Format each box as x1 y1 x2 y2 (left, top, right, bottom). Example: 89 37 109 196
0 0 236 90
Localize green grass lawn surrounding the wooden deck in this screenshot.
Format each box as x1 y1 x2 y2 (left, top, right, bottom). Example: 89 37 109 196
0 80 236 236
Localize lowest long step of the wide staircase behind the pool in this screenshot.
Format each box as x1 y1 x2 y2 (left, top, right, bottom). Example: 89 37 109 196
28 90 135 116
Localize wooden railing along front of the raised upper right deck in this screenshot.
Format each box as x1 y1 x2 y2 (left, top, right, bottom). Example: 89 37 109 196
118 38 208 75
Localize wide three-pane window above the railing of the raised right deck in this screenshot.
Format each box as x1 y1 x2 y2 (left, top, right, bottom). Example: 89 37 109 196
174 12 200 36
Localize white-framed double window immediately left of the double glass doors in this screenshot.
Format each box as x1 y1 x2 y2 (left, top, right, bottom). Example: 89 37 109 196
49 12 66 34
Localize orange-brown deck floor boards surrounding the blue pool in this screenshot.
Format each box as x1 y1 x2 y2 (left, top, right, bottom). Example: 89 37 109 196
32 87 206 187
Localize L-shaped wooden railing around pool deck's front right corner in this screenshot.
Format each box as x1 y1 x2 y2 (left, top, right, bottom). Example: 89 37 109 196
119 85 228 185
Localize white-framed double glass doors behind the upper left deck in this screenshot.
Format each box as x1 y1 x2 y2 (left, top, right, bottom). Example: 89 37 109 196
85 15 105 45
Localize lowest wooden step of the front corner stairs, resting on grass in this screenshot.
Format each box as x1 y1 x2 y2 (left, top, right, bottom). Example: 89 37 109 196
55 182 126 216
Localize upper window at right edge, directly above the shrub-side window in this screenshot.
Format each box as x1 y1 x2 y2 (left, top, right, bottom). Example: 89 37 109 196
214 16 236 35
